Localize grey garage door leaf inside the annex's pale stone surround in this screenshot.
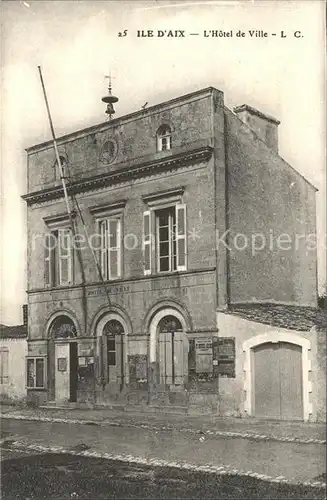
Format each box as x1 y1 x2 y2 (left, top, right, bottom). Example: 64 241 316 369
253 342 303 420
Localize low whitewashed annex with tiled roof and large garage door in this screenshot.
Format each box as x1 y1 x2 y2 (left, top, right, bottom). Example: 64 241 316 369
218 304 327 421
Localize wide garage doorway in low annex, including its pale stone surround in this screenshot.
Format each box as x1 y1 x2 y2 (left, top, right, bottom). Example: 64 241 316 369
243 330 312 421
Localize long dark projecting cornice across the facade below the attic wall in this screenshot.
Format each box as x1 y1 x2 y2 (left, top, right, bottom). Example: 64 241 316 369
22 146 213 205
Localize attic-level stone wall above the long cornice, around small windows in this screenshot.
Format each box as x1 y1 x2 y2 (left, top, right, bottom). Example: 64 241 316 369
28 90 217 192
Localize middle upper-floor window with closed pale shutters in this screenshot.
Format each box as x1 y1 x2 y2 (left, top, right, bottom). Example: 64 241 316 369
99 218 121 280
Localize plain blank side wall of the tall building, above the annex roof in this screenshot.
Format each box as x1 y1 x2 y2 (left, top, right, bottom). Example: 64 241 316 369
225 110 317 306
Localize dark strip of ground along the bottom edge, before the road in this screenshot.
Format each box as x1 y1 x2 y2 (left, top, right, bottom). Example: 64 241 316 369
2 454 326 500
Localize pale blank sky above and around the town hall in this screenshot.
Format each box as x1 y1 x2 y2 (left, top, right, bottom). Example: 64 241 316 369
0 0 326 324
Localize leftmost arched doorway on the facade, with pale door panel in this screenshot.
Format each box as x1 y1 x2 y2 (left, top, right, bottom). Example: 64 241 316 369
48 313 78 402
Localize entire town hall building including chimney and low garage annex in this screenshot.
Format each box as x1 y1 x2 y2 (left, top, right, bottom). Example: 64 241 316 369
23 87 325 421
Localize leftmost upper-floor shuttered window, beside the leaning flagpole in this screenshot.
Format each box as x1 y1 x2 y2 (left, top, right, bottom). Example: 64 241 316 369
44 228 73 286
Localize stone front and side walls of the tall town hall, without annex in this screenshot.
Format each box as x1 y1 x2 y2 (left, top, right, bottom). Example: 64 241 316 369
24 88 322 414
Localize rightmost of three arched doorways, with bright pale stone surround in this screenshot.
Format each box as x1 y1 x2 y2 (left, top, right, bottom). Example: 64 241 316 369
150 309 189 388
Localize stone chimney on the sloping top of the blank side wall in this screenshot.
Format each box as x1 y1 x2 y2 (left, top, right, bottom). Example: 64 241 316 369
234 104 280 153
